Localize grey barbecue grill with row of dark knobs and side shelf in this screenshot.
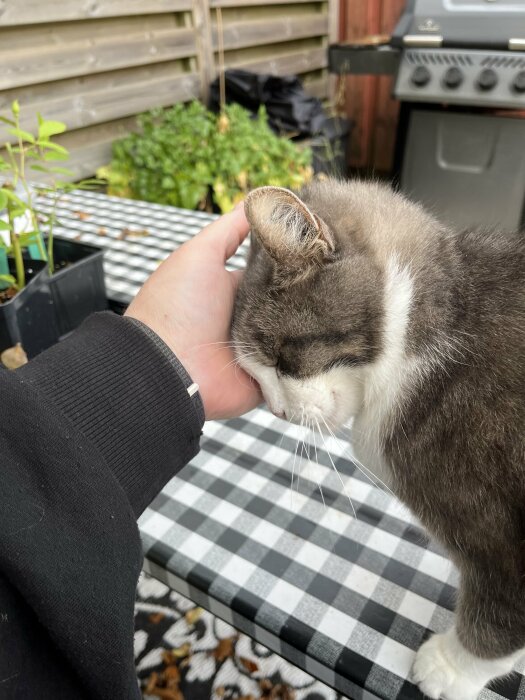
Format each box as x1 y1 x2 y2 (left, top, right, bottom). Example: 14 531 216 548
329 0 525 228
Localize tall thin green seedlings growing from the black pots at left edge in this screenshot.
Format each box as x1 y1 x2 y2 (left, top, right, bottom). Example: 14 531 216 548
0 100 99 291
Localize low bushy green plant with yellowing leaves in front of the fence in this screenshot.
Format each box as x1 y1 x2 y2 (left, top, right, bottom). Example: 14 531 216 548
97 101 312 212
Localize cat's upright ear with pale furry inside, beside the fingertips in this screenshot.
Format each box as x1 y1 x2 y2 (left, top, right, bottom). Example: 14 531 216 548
244 187 335 272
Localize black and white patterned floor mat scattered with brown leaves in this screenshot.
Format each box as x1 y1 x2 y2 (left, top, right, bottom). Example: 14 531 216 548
135 574 344 700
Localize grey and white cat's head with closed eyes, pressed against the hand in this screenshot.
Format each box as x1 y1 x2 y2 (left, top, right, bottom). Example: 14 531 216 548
232 180 390 428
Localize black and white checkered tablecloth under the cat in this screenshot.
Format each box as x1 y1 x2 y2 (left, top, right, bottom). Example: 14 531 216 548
37 192 525 700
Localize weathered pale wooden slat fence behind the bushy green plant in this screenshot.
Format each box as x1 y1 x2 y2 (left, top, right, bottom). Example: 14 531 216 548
0 0 338 178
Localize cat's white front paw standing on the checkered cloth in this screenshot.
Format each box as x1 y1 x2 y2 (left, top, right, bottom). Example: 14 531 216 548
412 633 483 700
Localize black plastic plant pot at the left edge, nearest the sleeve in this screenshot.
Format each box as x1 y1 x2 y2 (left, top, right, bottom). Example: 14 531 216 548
0 260 58 358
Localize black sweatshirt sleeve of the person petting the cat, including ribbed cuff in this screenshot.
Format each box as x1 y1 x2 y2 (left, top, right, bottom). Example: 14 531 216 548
0 313 204 700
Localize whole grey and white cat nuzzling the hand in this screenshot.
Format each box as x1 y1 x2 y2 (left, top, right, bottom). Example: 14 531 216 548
232 180 525 700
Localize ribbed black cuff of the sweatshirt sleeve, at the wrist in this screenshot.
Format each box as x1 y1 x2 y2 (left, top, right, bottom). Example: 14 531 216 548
16 312 204 516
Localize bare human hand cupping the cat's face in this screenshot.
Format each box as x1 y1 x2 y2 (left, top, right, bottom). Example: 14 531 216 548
125 206 263 420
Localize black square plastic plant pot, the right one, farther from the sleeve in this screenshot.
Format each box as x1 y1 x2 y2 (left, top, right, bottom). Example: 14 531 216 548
48 237 108 336
